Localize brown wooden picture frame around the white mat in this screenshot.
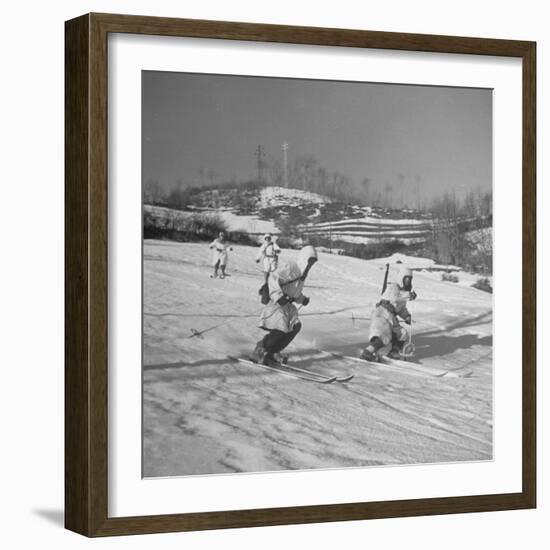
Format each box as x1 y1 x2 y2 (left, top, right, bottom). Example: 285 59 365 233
65 14 536 537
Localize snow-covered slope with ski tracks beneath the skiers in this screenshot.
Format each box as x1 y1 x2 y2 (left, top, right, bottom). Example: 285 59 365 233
143 241 492 477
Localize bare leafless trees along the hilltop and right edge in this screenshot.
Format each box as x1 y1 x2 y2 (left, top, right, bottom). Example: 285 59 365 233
143 145 492 272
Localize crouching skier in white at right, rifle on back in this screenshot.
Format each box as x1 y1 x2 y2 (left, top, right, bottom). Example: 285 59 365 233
360 266 416 361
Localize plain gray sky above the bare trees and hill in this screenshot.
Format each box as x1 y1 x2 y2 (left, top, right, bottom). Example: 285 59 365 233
142 71 492 203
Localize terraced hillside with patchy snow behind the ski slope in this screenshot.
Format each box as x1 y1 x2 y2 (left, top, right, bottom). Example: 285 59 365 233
144 186 492 275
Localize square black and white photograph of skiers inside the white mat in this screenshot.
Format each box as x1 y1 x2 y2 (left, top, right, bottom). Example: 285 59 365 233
141 71 496 478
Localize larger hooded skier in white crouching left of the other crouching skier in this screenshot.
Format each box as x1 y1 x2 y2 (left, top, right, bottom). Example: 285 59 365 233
252 246 317 365
